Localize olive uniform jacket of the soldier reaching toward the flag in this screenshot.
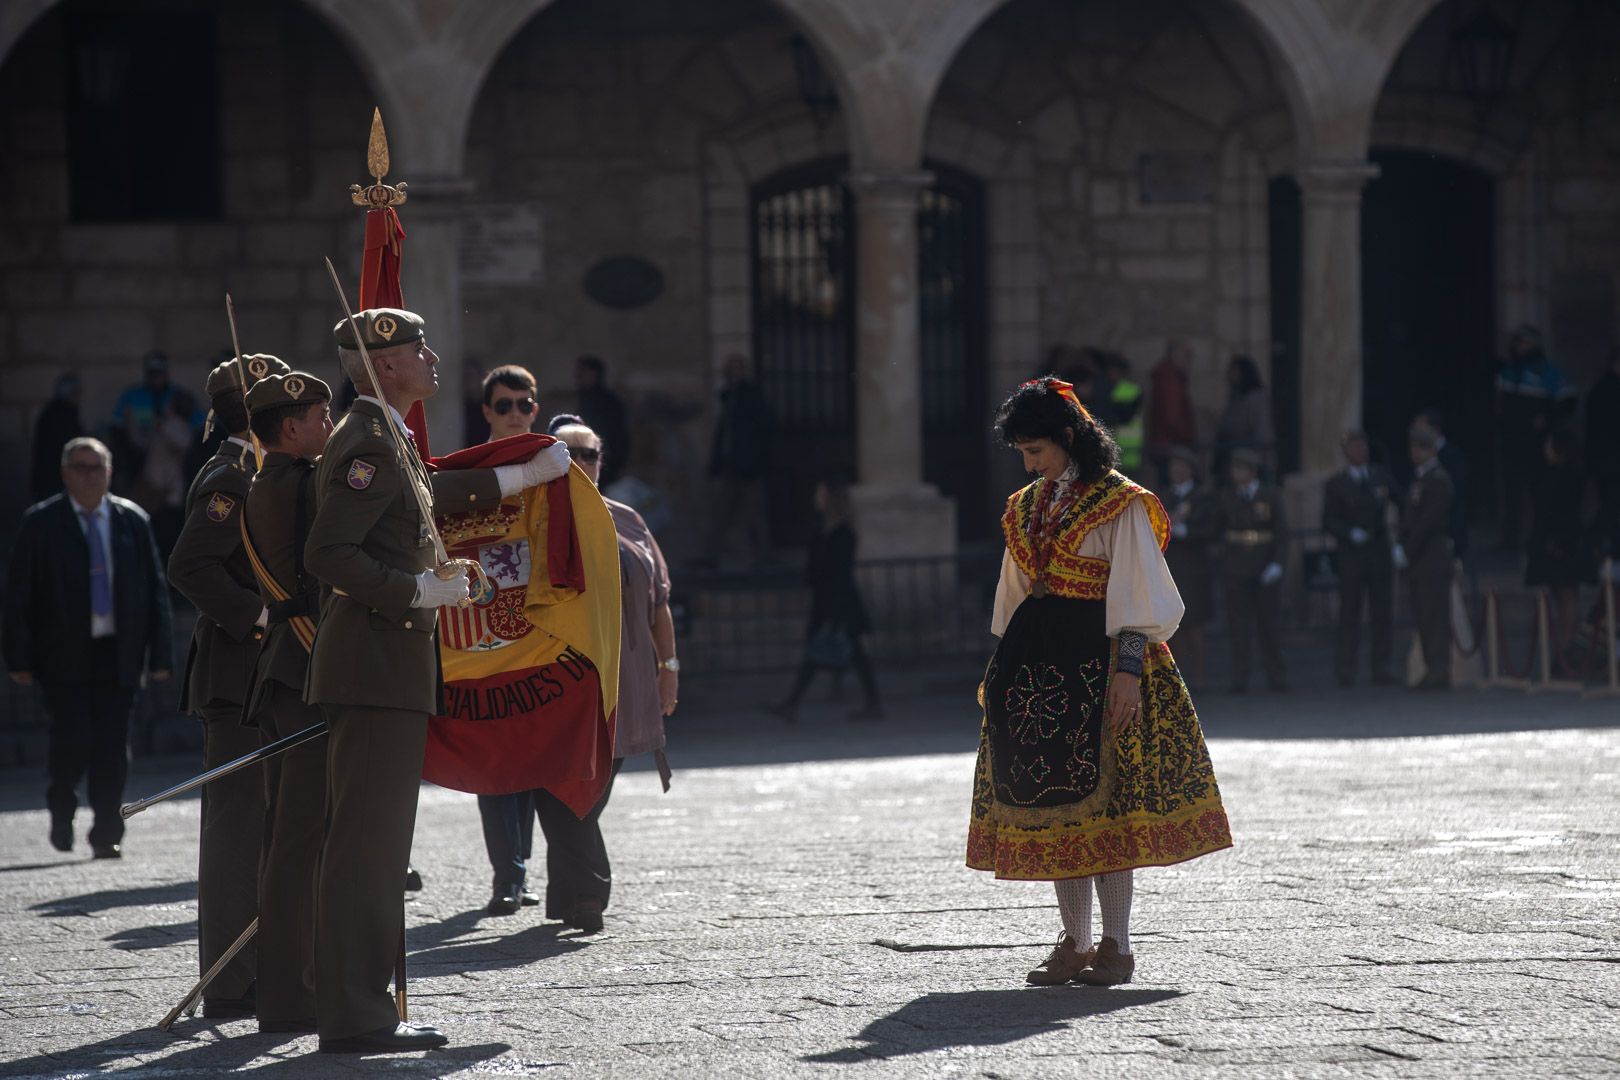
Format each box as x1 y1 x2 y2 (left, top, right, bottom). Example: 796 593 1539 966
305 402 501 712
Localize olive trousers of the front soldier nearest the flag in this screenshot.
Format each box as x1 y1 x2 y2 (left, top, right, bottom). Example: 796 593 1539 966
314 704 428 1040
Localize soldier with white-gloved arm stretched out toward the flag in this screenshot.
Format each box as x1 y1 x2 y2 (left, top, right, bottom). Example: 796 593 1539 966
305 308 569 1052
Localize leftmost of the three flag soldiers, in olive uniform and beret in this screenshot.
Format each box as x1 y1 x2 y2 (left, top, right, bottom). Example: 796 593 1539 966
168 355 288 1020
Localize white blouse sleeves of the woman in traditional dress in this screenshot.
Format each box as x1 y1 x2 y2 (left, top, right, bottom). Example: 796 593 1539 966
990 499 1186 641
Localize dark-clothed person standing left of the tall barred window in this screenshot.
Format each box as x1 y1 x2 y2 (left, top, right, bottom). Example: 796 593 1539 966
705 353 771 565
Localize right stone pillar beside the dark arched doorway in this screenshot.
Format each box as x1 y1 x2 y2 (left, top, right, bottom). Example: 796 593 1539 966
1299 160 1379 476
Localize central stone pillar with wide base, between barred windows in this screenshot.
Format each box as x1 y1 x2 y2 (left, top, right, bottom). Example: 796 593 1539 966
849 172 946 559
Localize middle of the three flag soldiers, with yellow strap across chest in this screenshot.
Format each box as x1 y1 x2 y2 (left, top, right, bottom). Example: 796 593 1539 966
245 371 332 1031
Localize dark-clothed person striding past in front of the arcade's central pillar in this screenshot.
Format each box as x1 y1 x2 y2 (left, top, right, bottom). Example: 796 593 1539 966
771 483 883 724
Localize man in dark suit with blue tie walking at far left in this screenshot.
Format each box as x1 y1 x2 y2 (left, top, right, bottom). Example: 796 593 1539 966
3 439 173 858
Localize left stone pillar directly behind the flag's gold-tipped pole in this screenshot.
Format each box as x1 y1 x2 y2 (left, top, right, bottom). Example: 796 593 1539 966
400 178 473 455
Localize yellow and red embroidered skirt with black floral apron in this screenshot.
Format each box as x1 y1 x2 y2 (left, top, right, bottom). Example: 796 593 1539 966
967 597 1231 881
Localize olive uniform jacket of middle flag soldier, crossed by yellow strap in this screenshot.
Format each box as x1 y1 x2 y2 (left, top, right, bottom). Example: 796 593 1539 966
245 453 321 721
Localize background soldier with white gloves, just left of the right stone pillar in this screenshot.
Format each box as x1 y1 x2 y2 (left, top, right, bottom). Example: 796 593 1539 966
1217 447 1288 693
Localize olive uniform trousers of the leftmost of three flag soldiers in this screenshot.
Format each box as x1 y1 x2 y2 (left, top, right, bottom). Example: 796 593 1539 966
198 704 264 1001
